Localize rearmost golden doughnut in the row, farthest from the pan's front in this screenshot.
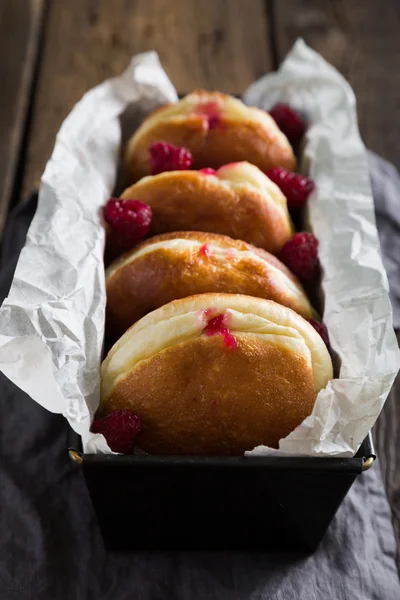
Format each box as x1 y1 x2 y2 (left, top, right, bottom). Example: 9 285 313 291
125 90 296 181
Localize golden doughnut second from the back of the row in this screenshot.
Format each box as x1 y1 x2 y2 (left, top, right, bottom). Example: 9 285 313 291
121 162 293 254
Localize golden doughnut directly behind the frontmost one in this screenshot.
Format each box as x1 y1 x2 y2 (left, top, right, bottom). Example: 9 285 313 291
106 231 312 336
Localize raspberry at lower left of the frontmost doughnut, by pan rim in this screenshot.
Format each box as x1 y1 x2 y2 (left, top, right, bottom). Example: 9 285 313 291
91 410 142 454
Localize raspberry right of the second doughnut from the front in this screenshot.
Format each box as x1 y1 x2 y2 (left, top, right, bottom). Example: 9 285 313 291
281 231 319 281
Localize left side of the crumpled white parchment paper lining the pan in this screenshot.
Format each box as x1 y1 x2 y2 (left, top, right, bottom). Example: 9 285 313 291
0 52 177 452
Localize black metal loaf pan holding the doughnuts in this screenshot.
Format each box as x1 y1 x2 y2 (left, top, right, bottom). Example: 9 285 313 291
69 431 375 552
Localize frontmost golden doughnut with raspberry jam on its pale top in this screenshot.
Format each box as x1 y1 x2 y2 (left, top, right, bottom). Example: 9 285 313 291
99 294 333 455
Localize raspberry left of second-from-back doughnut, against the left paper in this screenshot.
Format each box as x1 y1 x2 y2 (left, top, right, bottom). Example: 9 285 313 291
103 198 152 250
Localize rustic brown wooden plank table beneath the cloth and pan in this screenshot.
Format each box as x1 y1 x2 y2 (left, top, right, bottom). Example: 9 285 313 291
0 0 400 564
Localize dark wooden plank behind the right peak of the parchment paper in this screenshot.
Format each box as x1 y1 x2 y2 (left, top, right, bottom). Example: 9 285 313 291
273 0 400 168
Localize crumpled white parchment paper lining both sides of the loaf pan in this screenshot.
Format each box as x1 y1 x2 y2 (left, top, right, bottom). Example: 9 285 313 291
0 41 399 456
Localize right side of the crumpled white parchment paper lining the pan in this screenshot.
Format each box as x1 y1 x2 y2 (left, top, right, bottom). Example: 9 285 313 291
245 40 400 456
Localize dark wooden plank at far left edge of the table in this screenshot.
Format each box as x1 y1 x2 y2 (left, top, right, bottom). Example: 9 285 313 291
0 0 45 235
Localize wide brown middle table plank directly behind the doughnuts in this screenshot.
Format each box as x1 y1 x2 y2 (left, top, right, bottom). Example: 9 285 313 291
24 0 271 197
